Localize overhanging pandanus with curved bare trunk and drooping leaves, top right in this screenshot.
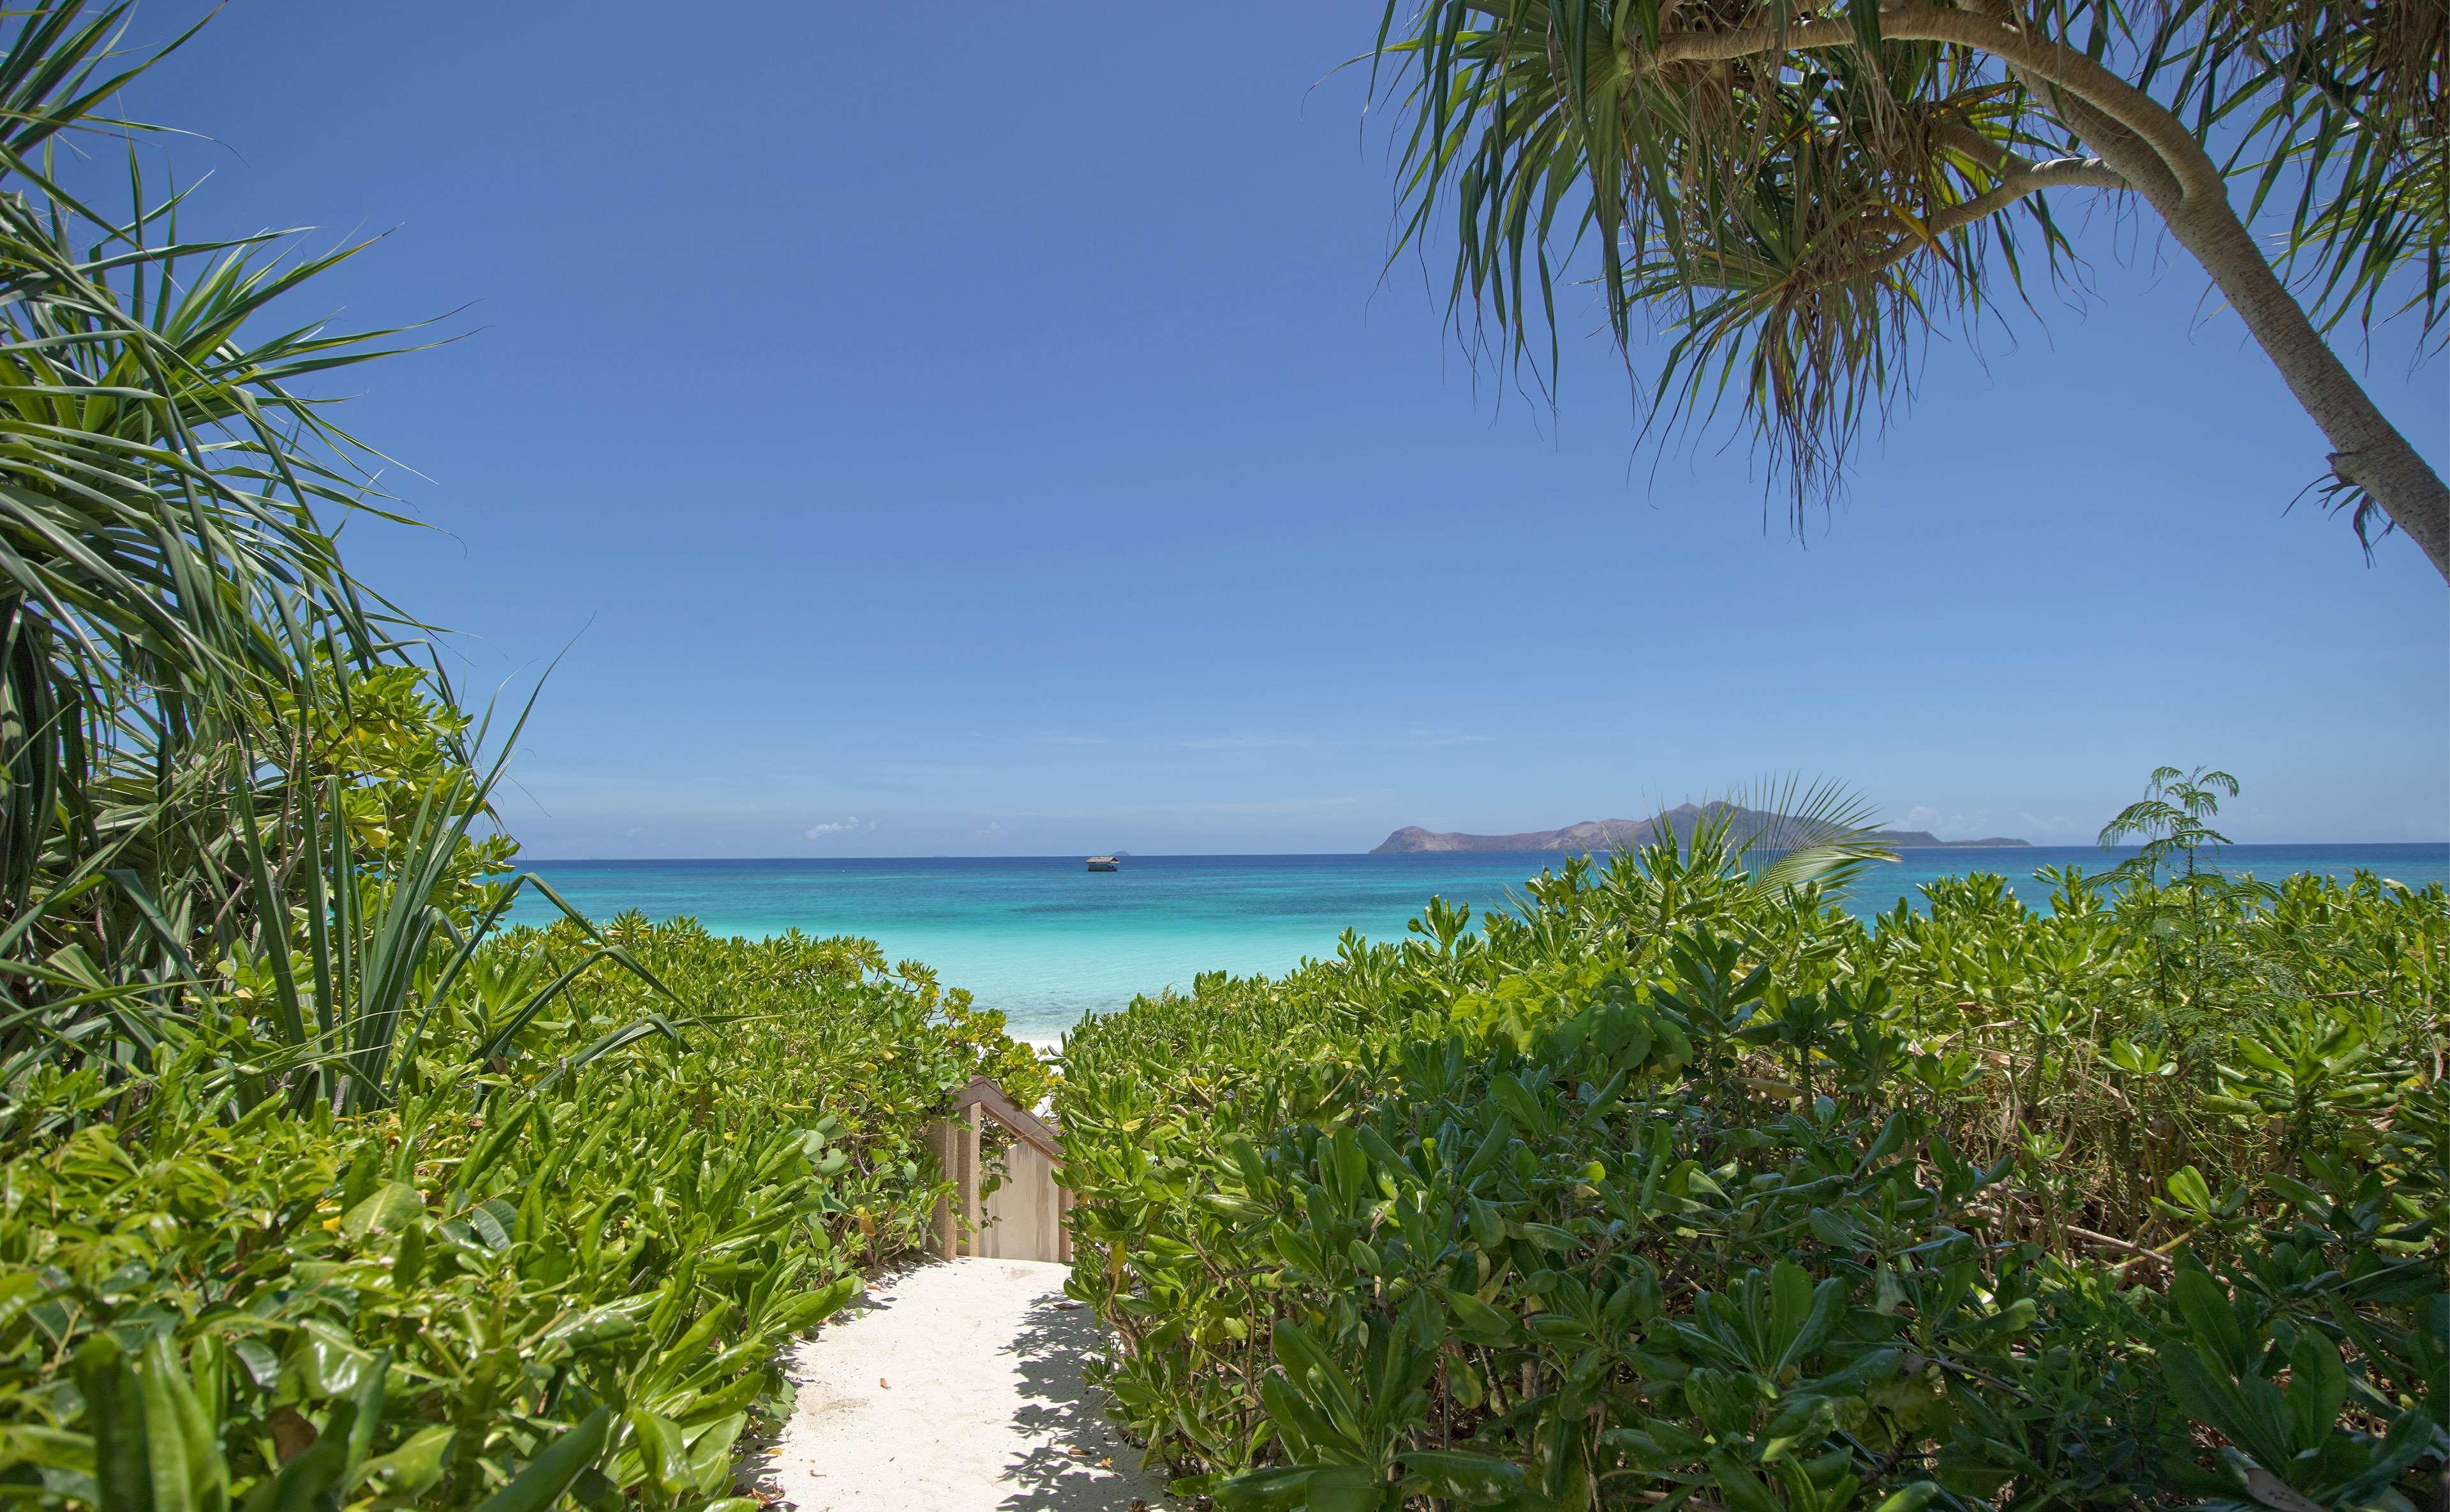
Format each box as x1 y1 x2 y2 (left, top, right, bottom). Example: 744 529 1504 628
1377 0 2450 579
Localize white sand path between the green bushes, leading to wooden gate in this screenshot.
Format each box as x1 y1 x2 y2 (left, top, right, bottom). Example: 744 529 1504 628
767 1259 1166 1512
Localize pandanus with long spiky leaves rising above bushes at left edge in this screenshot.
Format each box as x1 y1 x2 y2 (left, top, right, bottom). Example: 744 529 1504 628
0 0 671 1110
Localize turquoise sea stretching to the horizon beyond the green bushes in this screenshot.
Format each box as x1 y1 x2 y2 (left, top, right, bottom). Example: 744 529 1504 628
514 845 2450 1041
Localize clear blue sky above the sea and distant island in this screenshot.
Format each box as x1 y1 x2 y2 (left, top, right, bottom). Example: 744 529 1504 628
115 0 2450 857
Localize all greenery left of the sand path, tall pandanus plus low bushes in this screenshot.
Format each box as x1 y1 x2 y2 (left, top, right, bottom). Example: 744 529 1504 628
0 11 1039 1512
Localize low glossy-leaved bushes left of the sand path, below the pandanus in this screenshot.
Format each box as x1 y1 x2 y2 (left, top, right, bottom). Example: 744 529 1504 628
0 921 1034 1512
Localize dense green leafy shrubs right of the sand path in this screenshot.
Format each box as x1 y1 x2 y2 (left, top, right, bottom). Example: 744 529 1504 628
1058 823 2450 1512
